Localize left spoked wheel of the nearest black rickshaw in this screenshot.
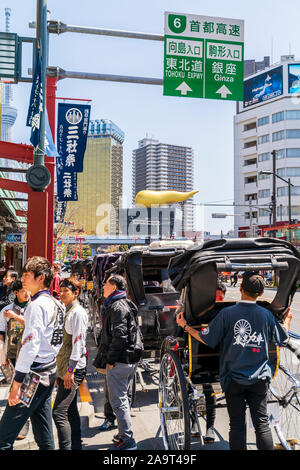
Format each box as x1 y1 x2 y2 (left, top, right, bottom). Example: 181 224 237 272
159 350 191 450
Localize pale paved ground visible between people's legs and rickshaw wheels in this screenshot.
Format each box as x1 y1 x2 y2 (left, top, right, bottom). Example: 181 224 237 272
0 335 264 451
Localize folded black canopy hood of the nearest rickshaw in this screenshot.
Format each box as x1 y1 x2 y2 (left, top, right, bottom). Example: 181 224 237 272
168 238 300 320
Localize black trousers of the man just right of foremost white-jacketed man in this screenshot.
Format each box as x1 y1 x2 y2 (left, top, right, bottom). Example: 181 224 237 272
53 368 86 450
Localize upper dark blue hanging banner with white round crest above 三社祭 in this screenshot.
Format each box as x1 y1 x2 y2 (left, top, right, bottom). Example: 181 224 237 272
57 103 91 173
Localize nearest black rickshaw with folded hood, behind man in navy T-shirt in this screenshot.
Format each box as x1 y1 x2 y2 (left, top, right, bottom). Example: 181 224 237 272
159 238 300 450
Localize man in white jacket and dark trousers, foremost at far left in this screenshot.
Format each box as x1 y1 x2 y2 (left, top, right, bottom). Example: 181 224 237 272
0 256 64 450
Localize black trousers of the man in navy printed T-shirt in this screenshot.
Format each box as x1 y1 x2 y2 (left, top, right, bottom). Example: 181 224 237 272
225 380 274 450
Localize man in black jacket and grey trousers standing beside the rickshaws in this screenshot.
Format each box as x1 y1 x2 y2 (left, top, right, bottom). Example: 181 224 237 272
93 275 143 450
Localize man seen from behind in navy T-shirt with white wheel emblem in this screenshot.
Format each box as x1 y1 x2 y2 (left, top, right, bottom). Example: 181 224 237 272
176 272 292 450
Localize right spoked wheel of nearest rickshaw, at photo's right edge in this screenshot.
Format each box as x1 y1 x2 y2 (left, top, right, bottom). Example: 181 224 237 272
270 336 300 450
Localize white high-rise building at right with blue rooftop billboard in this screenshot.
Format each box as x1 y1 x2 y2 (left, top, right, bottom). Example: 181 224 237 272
234 55 300 236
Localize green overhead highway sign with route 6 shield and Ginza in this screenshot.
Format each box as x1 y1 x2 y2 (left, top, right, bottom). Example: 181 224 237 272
164 12 244 101
